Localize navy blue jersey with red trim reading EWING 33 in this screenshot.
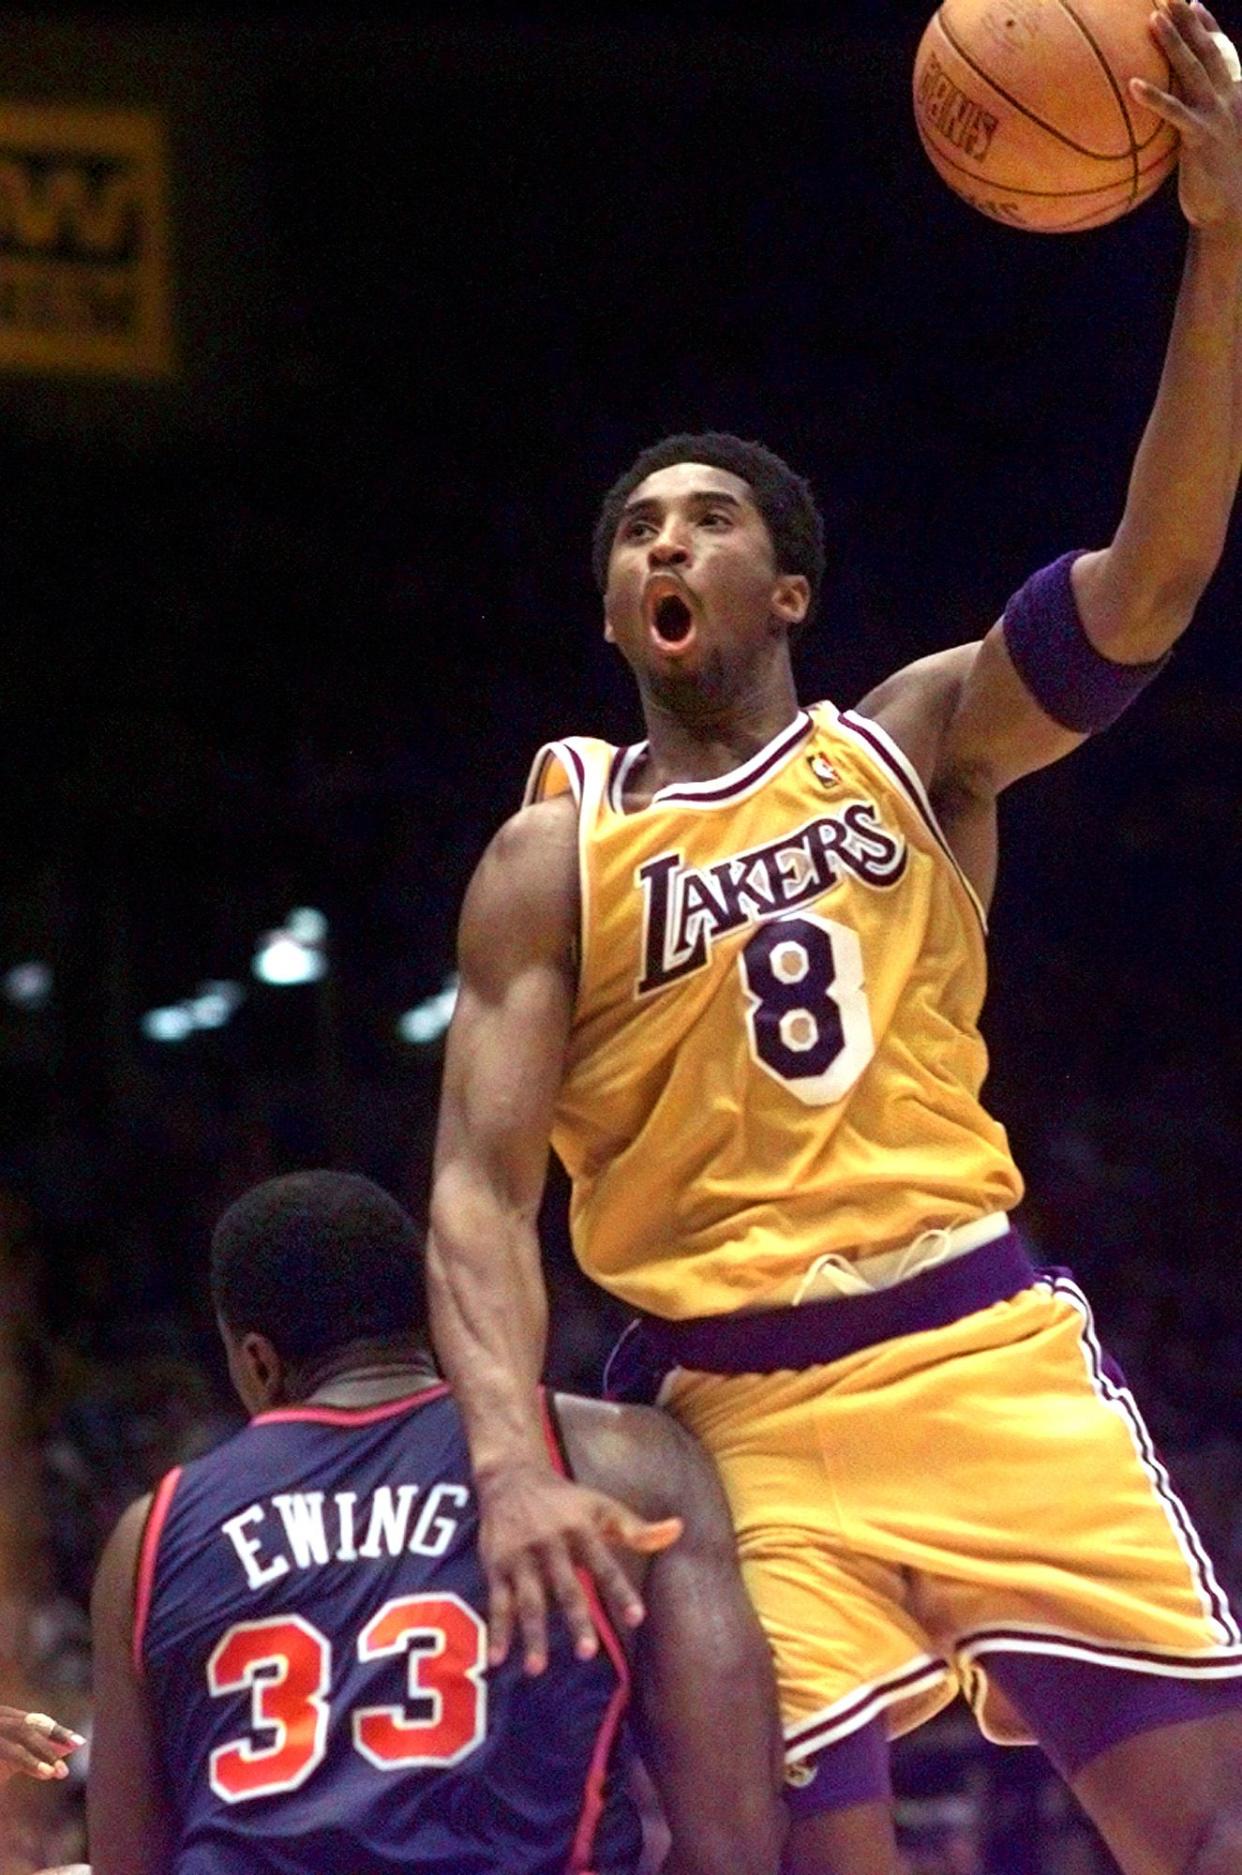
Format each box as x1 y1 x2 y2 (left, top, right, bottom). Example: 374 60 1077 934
133 1388 640 1875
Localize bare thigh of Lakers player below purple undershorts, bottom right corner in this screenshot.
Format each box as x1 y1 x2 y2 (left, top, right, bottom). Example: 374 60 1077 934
1073 1712 1242 1875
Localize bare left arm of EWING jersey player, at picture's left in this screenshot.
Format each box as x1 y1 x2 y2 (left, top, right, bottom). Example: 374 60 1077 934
86 1498 173 1875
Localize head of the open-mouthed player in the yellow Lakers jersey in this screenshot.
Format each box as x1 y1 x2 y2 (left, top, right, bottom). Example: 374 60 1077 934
595 431 824 707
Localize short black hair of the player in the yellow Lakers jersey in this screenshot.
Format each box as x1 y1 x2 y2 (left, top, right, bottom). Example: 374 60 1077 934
591 429 824 624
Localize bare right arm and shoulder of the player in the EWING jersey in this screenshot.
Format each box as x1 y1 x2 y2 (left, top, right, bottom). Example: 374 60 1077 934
557 1397 786 1875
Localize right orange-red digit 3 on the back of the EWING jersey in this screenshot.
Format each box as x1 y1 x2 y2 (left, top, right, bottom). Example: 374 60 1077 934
353 1596 488 1770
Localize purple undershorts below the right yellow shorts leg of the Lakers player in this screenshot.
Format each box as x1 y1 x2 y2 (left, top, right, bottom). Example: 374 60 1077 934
979 1652 1242 1778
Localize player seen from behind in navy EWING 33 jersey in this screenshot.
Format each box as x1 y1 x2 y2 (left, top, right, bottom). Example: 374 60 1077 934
88 1172 784 1875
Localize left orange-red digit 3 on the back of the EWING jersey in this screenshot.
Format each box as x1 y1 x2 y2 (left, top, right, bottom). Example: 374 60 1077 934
206 1614 332 1804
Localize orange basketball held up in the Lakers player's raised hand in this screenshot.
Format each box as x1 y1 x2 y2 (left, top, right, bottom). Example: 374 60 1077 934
914 0 1178 234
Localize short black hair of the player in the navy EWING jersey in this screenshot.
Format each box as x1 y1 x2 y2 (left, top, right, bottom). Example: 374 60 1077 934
212 1172 426 1365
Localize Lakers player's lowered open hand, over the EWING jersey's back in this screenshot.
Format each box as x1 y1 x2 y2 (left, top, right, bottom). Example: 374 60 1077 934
478 1464 681 1673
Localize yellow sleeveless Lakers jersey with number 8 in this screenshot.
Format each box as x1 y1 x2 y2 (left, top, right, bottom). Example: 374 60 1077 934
527 703 1022 1318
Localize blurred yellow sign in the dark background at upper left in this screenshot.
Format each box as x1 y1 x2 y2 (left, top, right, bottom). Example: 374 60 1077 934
0 103 173 377
